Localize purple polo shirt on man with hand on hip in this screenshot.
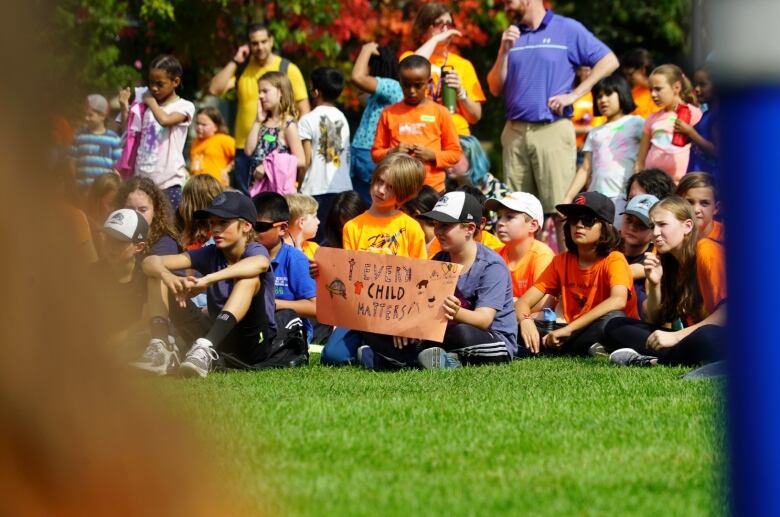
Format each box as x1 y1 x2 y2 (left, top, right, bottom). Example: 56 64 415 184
504 10 610 122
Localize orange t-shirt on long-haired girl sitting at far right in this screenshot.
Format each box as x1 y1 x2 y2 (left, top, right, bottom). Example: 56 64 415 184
681 238 726 327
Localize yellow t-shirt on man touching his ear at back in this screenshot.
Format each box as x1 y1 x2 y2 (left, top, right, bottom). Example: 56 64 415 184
234 56 309 149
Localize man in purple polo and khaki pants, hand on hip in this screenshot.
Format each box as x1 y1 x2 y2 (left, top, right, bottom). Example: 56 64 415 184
488 0 618 246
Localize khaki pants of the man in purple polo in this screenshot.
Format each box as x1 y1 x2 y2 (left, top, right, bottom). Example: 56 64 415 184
501 119 577 214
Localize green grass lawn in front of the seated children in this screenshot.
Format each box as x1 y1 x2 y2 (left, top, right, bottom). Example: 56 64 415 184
166 356 724 516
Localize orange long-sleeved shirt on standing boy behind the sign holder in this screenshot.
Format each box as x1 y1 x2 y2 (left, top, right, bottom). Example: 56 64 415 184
371 99 462 192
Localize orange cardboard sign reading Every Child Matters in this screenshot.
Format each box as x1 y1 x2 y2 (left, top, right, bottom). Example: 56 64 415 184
314 247 463 342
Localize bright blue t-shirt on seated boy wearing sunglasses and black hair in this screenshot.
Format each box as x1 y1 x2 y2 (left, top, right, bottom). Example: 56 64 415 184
271 243 317 338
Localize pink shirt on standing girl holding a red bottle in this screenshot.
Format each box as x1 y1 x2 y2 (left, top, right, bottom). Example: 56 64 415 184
642 104 701 184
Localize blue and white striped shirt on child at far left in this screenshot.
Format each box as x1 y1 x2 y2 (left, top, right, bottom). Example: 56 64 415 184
70 129 122 186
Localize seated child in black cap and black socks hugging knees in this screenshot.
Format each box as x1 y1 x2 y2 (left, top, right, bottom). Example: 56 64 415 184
136 192 274 378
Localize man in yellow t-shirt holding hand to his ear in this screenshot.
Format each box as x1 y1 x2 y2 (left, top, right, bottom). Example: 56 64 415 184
209 24 310 194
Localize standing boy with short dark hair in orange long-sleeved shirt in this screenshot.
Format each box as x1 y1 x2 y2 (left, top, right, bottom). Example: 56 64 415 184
371 55 462 192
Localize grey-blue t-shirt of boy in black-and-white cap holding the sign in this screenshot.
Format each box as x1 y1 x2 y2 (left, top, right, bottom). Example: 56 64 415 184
433 243 517 357
